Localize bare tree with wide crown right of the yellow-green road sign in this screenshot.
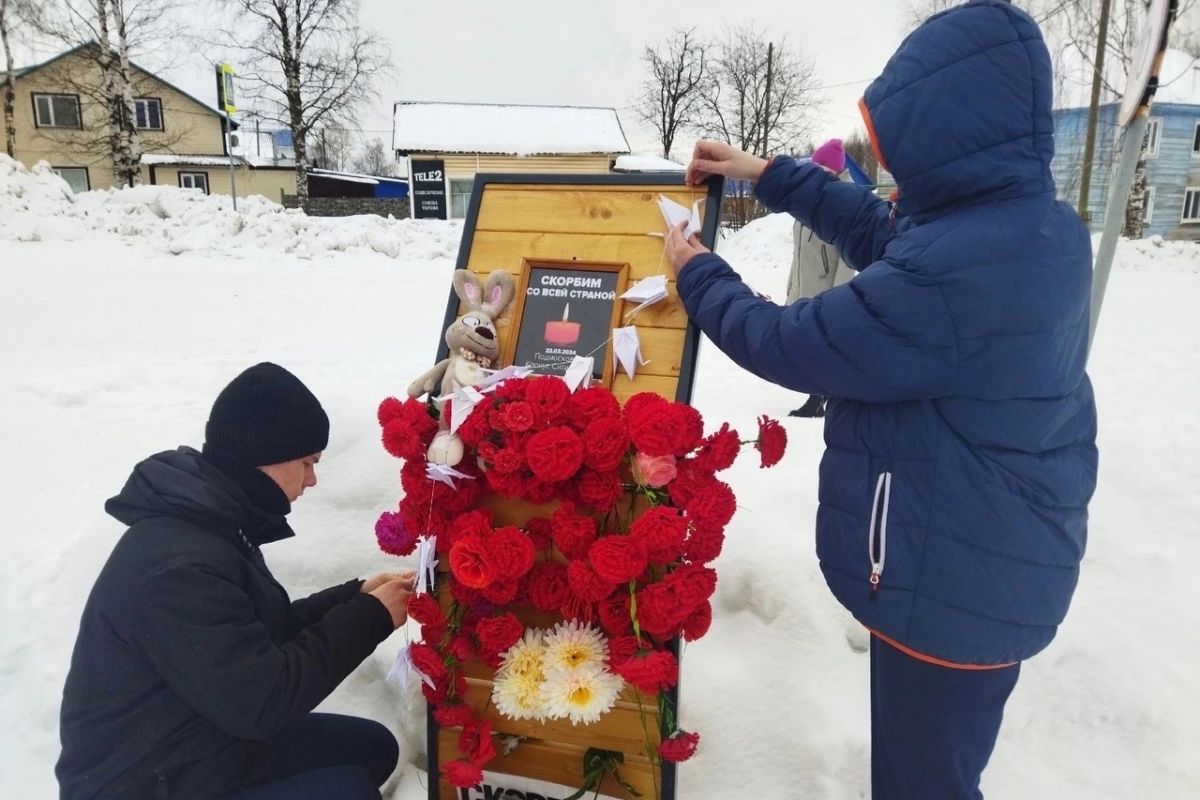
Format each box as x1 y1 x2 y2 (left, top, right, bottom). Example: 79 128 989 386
213 0 390 200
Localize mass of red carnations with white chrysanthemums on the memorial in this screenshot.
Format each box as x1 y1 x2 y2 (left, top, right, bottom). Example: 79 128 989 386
376 377 787 787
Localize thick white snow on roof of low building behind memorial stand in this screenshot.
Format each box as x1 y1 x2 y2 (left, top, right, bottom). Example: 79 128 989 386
391 102 629 156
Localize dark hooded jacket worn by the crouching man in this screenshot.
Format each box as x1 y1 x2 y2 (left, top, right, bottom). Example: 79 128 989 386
55 447 392 800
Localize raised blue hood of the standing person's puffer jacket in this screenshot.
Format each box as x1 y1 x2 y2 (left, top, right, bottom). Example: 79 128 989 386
860 0 1054 216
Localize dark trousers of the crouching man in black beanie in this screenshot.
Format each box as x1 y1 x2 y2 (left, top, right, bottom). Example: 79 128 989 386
230 714 400 800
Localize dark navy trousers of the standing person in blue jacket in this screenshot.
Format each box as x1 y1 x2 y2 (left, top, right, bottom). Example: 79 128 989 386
871 636 1021 800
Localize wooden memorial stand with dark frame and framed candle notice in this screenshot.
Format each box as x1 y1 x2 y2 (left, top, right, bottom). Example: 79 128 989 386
427 173 724 800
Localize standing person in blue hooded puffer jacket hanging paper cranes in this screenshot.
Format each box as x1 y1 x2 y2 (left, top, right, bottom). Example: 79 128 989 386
667 0 1097 800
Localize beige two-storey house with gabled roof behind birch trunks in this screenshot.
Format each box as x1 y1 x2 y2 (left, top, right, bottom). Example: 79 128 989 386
0 42 295 200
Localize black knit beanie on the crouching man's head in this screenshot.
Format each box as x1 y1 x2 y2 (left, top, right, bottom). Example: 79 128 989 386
204 362 329 467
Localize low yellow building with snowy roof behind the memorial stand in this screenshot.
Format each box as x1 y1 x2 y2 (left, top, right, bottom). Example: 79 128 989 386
392 102 629 218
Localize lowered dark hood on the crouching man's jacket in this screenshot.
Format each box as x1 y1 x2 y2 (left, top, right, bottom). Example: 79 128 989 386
104 447 293 545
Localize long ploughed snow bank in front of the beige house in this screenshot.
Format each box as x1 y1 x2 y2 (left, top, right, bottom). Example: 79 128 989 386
0 155 460 259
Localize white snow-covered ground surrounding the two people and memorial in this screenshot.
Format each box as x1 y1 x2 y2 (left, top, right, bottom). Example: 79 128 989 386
0 156 1200 800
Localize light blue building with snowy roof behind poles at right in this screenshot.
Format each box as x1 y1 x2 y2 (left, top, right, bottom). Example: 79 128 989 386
1051 50 1200 240
